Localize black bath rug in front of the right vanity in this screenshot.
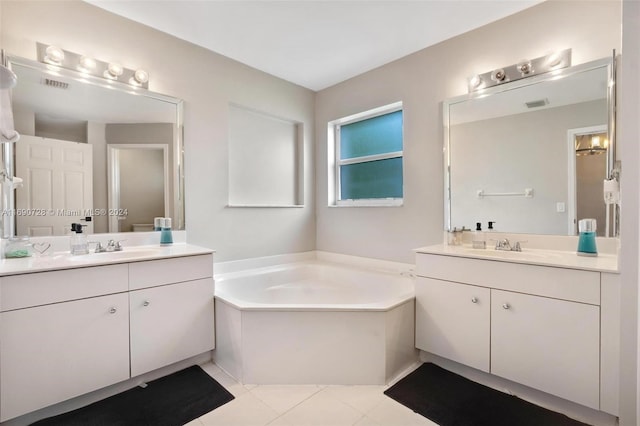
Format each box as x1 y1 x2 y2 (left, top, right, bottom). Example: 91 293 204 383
384 363 586 426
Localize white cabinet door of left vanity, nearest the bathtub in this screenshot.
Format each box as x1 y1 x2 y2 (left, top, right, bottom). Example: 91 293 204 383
129 278 214 377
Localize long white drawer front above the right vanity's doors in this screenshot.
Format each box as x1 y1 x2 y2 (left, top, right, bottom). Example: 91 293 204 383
416 254 600 305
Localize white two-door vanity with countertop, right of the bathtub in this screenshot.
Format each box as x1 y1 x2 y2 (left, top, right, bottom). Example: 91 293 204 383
416 245 620 415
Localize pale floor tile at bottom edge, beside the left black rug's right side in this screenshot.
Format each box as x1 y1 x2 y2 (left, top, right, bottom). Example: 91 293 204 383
199 391 278 426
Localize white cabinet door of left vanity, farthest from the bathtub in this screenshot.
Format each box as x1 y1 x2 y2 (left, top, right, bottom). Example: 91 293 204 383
0 293 129 421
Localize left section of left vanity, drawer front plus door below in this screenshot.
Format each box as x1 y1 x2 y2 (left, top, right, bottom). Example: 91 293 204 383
0 265 129 421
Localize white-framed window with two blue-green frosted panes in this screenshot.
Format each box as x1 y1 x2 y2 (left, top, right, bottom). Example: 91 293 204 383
332 103 403 206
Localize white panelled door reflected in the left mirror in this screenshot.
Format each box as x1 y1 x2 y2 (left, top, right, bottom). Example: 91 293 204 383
15 135 93 236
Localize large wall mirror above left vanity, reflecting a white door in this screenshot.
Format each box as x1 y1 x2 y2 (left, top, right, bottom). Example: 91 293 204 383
3 57 184 236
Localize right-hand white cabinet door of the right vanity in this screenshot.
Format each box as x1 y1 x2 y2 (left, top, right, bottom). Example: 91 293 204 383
491 290 600 409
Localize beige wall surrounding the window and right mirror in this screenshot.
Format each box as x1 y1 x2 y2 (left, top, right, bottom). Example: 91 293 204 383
316 0 621 262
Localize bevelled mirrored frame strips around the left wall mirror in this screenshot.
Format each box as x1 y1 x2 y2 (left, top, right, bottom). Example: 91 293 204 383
1 54 186 238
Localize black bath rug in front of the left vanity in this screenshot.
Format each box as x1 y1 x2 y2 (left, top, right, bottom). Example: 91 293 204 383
33 365 233 426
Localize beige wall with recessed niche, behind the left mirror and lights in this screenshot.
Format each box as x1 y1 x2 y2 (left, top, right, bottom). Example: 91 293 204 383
0 0 315 261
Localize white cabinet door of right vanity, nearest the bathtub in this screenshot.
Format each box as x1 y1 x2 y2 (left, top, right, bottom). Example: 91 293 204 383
416 277 490 372
